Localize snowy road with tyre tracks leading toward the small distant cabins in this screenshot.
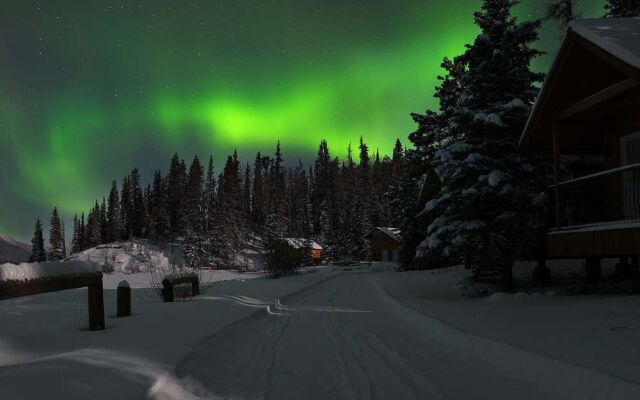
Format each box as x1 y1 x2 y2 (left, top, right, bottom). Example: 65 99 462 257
151 274 640 400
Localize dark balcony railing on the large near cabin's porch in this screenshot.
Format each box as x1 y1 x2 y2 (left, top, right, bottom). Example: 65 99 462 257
551 163 640 228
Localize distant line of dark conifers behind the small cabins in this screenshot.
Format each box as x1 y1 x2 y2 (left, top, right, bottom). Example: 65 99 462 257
34 137 405 267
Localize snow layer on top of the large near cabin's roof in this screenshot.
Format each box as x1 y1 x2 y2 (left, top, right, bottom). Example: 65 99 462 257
569 17 640 69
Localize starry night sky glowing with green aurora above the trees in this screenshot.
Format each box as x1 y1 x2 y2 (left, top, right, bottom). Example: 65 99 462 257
0 0 603 241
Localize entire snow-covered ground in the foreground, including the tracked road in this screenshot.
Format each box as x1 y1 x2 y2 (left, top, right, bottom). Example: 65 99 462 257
0 264 640 400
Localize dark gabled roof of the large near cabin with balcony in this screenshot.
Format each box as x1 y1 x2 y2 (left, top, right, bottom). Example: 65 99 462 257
520 17 640 153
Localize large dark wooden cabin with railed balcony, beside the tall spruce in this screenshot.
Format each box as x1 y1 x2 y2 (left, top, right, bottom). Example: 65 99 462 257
520 18 640 280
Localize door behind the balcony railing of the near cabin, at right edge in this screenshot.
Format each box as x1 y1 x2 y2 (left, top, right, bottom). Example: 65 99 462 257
620 132 640 220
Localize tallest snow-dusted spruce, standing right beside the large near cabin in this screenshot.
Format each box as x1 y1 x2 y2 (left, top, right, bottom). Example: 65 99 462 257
419 0 545 290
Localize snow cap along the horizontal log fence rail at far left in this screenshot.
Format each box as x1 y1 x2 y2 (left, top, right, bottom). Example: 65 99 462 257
0 261 101 282
